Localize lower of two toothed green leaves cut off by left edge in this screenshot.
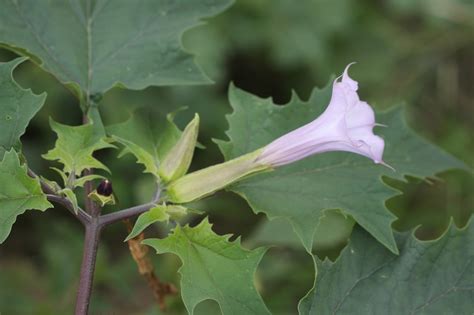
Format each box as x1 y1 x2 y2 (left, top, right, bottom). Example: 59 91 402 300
0 150 52 243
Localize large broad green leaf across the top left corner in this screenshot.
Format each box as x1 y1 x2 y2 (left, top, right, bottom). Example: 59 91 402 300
0 0 232 98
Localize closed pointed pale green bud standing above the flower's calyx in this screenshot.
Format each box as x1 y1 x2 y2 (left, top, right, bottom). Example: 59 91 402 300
158 114 199 182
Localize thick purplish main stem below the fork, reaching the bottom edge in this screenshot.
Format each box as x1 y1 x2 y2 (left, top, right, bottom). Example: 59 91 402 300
75 217 102 315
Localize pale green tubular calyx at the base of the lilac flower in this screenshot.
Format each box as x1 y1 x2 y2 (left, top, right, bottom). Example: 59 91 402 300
167 150 272 203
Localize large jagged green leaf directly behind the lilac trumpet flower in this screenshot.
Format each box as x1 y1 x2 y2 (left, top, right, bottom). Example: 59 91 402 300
218 86 464 253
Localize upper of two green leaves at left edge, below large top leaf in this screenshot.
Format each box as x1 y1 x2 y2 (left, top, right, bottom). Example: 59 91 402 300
0 57 46 159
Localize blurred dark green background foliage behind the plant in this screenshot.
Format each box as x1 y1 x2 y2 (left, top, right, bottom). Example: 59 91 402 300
0 0 474 315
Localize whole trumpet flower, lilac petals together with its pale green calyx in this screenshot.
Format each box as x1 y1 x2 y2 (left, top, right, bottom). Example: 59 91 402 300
167 65 386 203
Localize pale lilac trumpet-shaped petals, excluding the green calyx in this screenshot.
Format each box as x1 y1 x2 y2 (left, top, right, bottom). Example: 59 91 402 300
257 64 386 166
